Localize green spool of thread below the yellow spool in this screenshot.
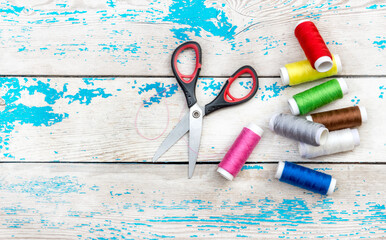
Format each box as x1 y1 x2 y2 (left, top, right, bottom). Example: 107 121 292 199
288 79 348 115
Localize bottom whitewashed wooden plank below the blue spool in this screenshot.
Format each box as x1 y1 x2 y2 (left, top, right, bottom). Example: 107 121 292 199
0 164 386 239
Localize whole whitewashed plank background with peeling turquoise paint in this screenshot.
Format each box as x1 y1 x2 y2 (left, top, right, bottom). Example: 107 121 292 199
0 0 386 239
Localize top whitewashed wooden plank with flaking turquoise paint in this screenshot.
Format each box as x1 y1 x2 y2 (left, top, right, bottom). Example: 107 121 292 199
0 0 386 76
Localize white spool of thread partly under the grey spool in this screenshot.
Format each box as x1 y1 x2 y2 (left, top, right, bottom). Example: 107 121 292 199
299 128 360 158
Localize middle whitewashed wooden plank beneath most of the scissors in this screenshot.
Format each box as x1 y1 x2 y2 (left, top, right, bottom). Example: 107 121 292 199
0 78 386 162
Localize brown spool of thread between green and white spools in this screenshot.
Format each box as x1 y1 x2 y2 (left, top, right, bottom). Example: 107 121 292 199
306 106 367 131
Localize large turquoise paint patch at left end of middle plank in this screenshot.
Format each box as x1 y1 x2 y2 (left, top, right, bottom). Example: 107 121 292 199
0 78 112 158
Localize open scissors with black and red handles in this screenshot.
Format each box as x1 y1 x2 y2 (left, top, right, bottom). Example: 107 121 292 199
153 41 259 178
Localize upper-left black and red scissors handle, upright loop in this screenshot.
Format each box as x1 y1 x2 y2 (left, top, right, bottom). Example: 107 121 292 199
172 41 201 108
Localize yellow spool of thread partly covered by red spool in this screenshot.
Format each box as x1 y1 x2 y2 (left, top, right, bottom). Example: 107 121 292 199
280 55 342 86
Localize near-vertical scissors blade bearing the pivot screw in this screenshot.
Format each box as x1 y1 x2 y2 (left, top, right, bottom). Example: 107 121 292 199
188 103 204 178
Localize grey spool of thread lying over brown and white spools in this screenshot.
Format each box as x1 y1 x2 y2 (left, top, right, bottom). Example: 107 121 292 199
269 113 328 146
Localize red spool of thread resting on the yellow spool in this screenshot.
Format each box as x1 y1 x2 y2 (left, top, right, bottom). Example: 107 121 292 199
295 20 333 72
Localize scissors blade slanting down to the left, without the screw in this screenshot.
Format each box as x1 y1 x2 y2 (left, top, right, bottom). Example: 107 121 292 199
153 113 190 162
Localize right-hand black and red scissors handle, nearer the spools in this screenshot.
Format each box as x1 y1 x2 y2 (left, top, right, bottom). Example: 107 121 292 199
205 66 259 115
